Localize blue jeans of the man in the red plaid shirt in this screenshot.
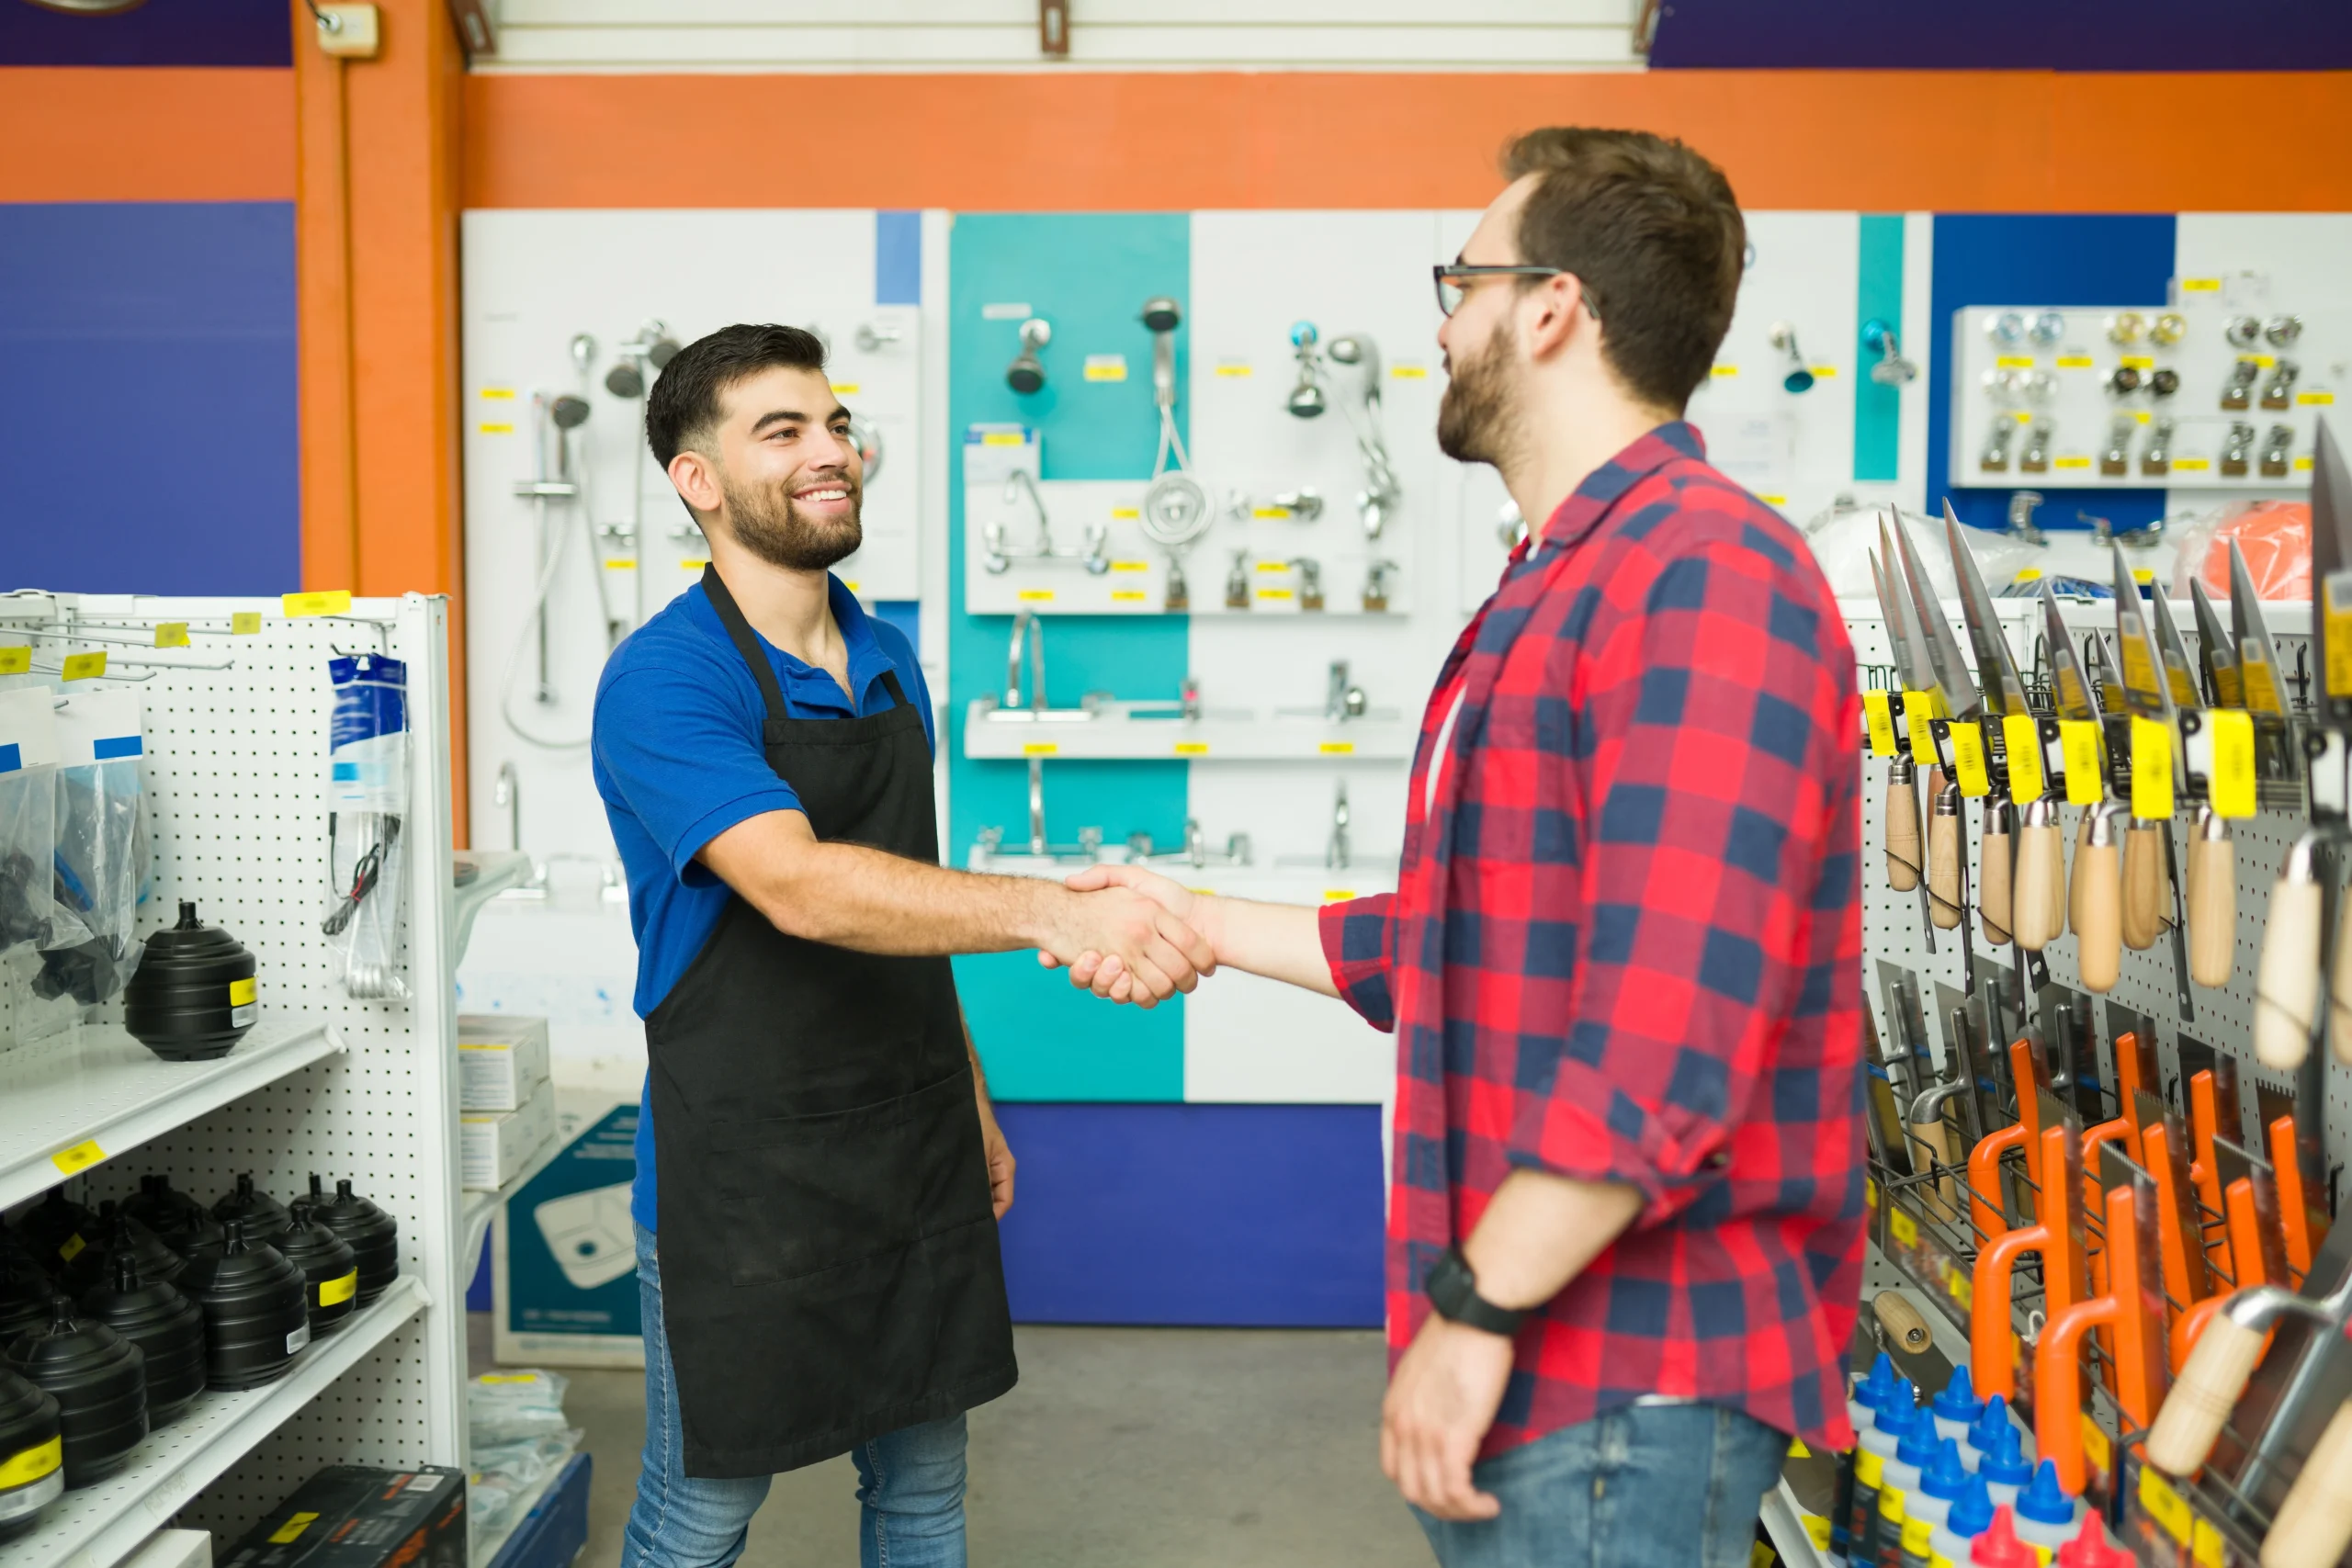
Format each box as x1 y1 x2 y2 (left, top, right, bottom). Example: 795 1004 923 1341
1414 1404 1788 1568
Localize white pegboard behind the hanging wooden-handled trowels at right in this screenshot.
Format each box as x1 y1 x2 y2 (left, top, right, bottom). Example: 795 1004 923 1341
1844 587 2352 1189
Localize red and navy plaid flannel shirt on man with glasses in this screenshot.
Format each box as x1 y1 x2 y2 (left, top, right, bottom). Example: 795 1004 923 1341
1322 423 1863 1455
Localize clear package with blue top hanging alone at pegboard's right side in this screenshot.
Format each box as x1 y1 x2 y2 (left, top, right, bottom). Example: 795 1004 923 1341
320 653 409 999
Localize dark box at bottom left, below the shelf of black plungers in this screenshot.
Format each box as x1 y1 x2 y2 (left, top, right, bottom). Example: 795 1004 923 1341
221 1464 466 1568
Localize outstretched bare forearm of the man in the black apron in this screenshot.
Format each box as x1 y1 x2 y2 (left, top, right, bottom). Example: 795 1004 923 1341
752 841 1072 957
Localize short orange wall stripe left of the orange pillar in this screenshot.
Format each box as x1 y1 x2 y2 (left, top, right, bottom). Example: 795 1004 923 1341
0 66 294 202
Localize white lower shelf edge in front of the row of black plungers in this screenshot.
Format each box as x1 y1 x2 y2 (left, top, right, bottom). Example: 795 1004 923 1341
0 1274 430 1568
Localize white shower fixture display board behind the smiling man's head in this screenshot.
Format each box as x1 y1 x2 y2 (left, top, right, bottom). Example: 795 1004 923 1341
463 209 924 858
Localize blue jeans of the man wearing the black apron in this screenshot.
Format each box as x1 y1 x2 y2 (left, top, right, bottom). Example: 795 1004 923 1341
621 1224 965 1568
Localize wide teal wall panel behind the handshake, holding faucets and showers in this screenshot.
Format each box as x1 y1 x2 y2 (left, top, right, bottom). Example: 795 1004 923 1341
948 211 1193 1100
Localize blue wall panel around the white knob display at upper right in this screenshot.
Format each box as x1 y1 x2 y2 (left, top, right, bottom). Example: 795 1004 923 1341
1927 214 2176 540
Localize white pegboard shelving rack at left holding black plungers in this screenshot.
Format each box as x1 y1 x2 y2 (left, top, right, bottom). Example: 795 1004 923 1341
0 594 472 1568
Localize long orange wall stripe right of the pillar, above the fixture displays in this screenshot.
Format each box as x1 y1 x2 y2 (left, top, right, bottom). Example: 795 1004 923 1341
463 71 2352 211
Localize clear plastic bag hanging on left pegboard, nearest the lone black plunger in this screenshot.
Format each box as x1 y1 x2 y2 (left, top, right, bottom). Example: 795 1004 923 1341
33 689 151 1006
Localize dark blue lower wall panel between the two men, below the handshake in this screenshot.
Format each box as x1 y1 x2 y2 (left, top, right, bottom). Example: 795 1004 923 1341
1000 1105 1383 1328
